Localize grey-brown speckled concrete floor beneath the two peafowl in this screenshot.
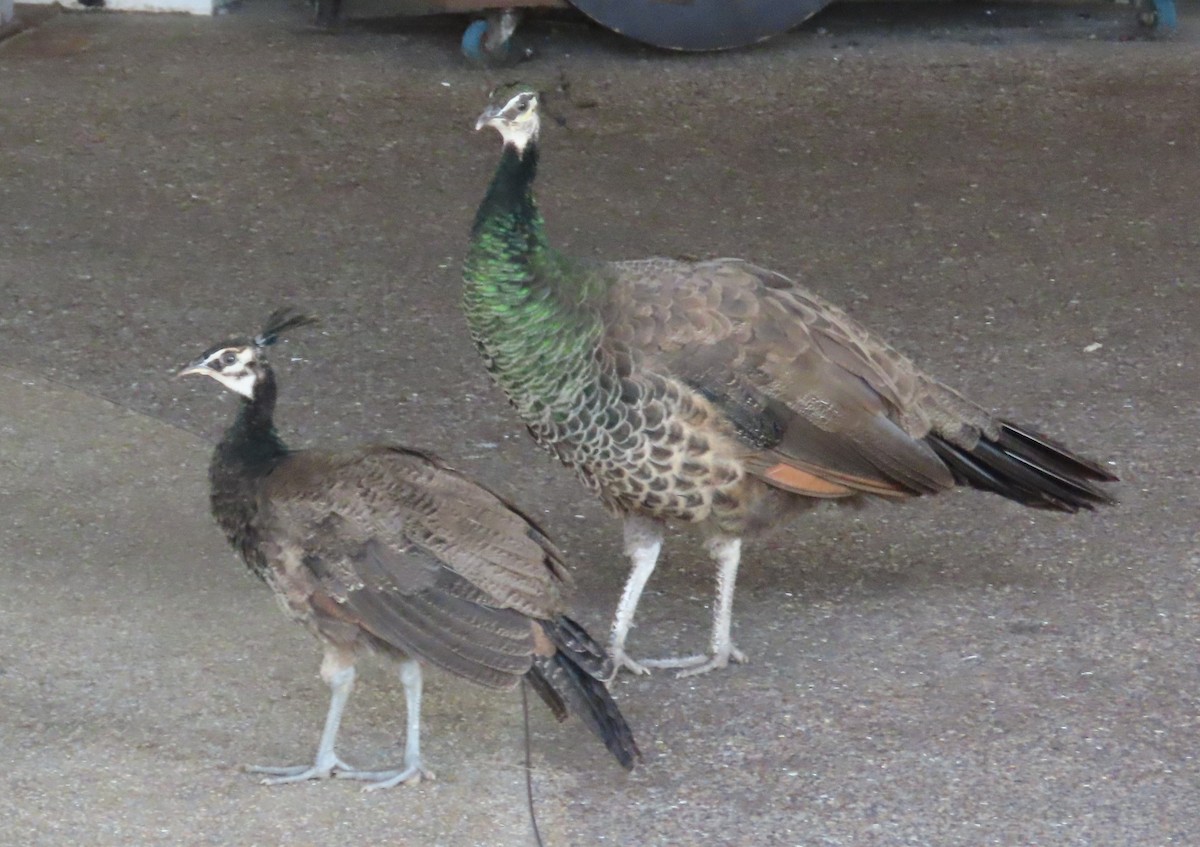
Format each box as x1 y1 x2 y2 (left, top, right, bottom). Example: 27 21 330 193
0 0 1200 847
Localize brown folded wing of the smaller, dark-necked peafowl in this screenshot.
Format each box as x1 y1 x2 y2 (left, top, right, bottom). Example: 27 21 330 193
263 447 568 686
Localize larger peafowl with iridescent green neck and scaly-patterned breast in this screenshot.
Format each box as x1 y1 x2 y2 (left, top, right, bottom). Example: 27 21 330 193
463 84 1116 674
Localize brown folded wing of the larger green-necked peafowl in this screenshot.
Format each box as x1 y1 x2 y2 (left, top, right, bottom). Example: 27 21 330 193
606 259 989 497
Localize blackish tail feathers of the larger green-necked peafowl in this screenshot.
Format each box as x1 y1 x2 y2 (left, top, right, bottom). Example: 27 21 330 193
925 421 1117 512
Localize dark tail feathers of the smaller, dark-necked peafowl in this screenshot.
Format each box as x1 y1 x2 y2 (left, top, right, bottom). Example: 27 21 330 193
526 618 642 770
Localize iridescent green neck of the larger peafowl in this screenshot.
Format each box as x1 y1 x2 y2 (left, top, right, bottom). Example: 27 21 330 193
463 143 607 419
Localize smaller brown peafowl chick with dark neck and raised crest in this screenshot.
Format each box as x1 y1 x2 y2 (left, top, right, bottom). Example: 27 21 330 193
179 311 640 788
